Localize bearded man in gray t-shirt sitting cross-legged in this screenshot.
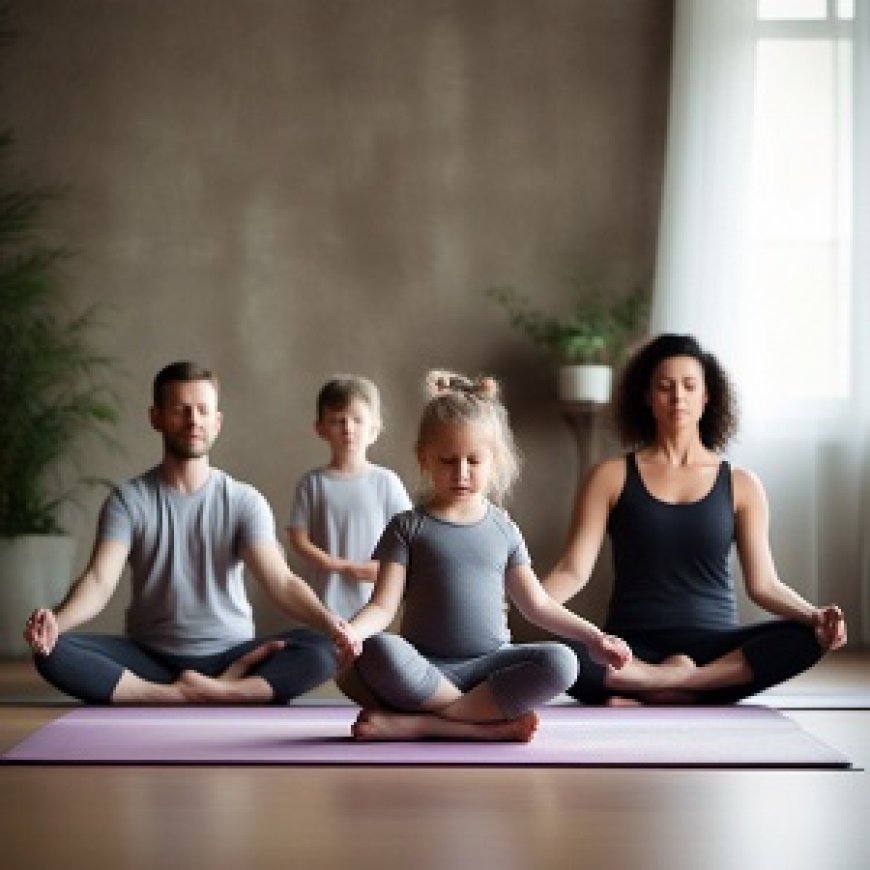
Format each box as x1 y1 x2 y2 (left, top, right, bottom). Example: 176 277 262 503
24 362 358 704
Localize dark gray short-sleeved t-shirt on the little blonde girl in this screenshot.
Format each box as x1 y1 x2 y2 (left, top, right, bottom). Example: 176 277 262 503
375 505 530 658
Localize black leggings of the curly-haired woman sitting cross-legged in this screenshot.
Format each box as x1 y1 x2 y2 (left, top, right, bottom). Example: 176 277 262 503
563 620 824 704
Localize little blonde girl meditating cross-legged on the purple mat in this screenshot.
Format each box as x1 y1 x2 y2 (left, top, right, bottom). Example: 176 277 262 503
336 372 631 741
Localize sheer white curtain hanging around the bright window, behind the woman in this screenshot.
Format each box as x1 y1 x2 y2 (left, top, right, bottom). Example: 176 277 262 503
652 0 870 643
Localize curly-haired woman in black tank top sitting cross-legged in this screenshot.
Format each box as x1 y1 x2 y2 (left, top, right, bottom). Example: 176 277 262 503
544 335 846 704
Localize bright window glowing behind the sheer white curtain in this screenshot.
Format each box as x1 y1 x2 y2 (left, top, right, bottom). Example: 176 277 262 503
741 0 854 416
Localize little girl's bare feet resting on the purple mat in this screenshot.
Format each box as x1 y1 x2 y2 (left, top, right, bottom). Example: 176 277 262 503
351 710 540 743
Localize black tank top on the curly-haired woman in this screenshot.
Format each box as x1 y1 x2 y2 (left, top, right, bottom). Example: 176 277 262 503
607 453 737 633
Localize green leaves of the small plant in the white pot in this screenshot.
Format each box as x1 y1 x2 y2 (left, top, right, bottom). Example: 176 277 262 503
486 284 649 365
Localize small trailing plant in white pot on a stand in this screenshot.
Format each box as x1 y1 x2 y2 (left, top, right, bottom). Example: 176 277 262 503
487 282 649 403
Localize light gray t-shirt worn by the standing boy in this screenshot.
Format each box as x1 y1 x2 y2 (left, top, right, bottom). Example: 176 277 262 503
287 465 411 619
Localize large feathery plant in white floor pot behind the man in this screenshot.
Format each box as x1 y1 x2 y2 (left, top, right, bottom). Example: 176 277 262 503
0 133 118 656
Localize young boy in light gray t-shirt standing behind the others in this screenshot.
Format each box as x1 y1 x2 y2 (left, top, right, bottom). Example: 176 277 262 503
287 375 411 619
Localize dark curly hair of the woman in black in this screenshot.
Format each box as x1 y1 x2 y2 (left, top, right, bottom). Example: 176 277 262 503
613 333 739 452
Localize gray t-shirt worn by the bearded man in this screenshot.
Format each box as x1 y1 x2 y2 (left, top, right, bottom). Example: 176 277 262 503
98 468 276 655
